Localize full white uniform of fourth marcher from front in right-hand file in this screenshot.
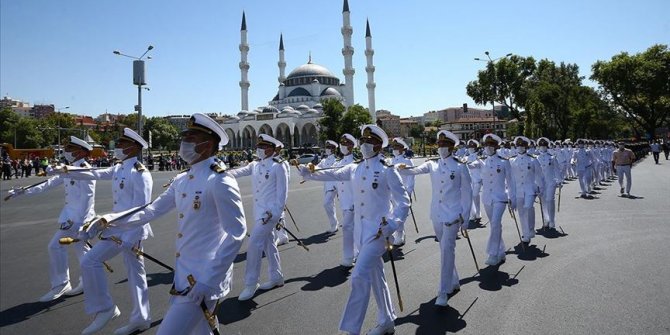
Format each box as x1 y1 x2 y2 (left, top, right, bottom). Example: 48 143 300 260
510 153 545 242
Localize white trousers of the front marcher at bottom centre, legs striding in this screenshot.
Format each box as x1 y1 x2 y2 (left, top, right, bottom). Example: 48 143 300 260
340 237 396 334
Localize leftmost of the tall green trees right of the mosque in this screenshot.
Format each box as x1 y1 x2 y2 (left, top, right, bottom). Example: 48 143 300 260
466 55 535 118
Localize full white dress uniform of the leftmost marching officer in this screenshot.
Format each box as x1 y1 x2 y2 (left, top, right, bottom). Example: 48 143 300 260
24 158 95 289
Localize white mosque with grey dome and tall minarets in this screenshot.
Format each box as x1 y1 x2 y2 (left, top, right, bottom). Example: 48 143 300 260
222 0 376 149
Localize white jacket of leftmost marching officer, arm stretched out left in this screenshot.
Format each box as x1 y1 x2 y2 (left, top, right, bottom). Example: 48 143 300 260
24 159 95 228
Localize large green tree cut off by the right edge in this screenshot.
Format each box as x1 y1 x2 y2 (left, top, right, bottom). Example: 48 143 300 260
591 44 670 138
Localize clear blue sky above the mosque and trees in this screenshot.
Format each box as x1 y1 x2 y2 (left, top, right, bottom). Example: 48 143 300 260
0 0 670 116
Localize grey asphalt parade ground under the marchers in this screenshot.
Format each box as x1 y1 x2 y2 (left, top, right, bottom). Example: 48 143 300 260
0 156 670 335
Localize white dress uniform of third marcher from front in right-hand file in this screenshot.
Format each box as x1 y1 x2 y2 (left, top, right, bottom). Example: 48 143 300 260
481 154 516 262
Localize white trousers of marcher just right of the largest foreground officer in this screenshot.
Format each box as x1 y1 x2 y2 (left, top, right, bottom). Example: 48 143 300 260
244 220 284 286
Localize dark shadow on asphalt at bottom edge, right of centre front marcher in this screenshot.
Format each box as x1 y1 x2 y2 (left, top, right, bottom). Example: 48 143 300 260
395 299 467 335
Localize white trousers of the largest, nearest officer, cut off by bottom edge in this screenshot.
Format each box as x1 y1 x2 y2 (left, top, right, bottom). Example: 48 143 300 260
156 296 216 335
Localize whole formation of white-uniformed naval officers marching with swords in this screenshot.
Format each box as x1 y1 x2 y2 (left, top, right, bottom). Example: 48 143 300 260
5 113 639 335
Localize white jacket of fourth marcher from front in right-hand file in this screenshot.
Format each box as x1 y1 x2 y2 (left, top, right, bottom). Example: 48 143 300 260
510 154 544 198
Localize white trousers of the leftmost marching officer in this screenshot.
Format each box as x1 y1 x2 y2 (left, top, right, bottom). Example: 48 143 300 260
49 225 90 288
